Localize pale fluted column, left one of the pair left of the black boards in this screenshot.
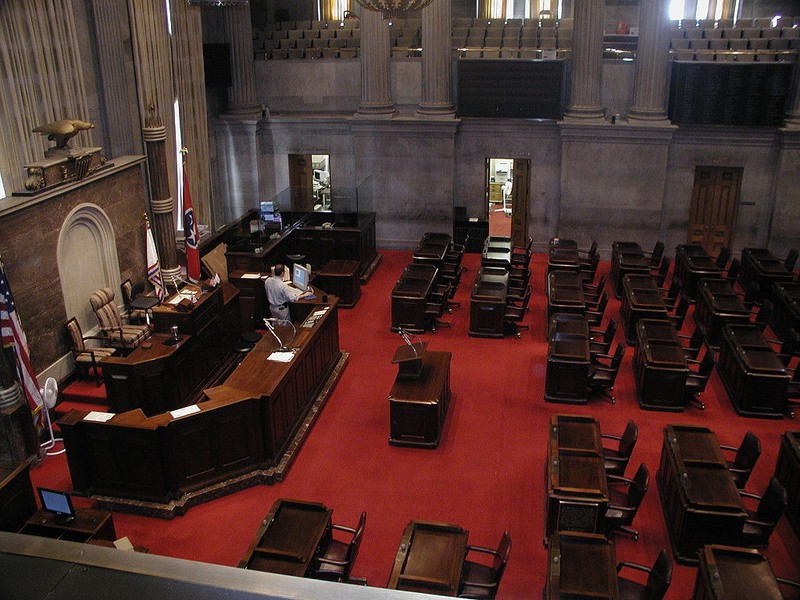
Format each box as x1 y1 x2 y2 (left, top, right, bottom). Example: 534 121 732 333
356 8 397 118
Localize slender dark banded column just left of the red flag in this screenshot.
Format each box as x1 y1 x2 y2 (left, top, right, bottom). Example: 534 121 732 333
142 107 181 281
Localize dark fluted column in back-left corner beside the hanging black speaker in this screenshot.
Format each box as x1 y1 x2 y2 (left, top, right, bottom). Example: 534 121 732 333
224 5 261 118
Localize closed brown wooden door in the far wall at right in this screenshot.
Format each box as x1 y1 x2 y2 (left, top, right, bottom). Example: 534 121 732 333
686 167 742 257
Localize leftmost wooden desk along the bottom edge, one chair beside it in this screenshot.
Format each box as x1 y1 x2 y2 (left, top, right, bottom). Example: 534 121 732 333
239 498 333 577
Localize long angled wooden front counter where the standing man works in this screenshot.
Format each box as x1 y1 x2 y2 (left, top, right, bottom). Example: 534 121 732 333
58 299 344 513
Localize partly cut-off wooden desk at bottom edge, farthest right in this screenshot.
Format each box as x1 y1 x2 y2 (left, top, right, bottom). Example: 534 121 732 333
692 545 783 600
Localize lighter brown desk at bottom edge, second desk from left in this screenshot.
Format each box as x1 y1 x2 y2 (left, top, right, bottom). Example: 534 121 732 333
386 521 469 596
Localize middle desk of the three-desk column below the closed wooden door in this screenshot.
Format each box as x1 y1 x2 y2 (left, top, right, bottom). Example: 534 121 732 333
693 279 750 348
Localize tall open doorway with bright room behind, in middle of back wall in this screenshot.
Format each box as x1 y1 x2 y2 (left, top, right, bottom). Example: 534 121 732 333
486 158 530 246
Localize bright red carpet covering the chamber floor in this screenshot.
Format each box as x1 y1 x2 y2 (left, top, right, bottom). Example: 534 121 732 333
32 251 800 598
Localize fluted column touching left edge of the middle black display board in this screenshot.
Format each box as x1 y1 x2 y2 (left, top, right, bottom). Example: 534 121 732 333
417 0 455 116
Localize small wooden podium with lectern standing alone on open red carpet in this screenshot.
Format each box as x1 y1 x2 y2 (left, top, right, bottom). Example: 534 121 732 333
389 342 452 448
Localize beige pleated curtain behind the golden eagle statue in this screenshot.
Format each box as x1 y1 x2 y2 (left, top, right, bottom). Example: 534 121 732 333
0 0 93 194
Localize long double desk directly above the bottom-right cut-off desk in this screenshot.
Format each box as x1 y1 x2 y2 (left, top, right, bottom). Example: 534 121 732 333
656 425 747 565
